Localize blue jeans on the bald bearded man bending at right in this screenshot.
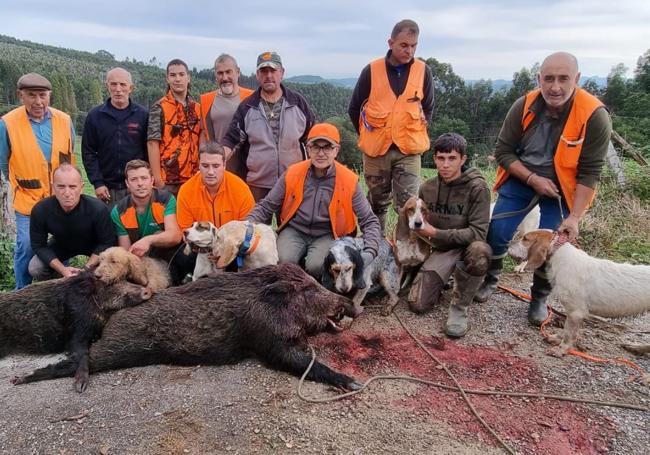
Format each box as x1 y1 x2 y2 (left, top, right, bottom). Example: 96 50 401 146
487 177 569 258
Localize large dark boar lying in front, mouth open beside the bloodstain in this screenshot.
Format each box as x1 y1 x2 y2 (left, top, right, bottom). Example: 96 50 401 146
20 264 358 389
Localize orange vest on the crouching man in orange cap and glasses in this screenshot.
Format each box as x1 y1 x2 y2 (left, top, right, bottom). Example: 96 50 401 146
278 160 359 238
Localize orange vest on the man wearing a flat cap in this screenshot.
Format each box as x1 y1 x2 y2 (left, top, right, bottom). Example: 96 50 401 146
2 107 75 216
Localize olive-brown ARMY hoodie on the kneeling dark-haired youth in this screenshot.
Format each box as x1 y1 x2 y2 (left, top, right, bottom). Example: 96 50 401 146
419 167 490 251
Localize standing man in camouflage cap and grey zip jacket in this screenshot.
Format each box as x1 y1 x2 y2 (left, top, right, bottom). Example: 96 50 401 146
223 52 314 201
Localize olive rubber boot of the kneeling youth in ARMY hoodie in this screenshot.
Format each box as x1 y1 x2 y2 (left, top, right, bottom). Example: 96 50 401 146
445 262 483 338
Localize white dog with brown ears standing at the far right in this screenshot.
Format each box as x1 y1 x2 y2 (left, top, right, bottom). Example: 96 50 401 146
508 230 650 356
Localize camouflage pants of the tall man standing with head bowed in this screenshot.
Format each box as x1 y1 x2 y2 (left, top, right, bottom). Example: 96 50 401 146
363 149 421 231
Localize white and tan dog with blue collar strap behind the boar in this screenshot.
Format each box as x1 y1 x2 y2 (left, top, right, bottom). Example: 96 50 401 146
212 221 279 270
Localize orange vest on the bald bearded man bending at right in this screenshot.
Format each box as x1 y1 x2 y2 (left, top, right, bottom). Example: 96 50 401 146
494 88 603 210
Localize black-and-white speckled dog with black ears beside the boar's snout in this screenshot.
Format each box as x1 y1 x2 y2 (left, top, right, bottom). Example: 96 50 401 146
321 237 400 316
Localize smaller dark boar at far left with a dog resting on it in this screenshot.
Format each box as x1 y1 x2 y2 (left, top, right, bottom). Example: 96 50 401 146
0 272 151 392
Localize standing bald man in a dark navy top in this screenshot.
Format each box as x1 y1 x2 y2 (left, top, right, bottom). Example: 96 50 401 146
81 67 149 207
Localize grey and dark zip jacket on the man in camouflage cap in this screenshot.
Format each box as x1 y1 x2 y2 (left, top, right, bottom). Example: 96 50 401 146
222 84 315 189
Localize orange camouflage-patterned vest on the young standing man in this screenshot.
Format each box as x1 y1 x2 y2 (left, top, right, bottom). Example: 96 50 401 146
157 91 201 183
